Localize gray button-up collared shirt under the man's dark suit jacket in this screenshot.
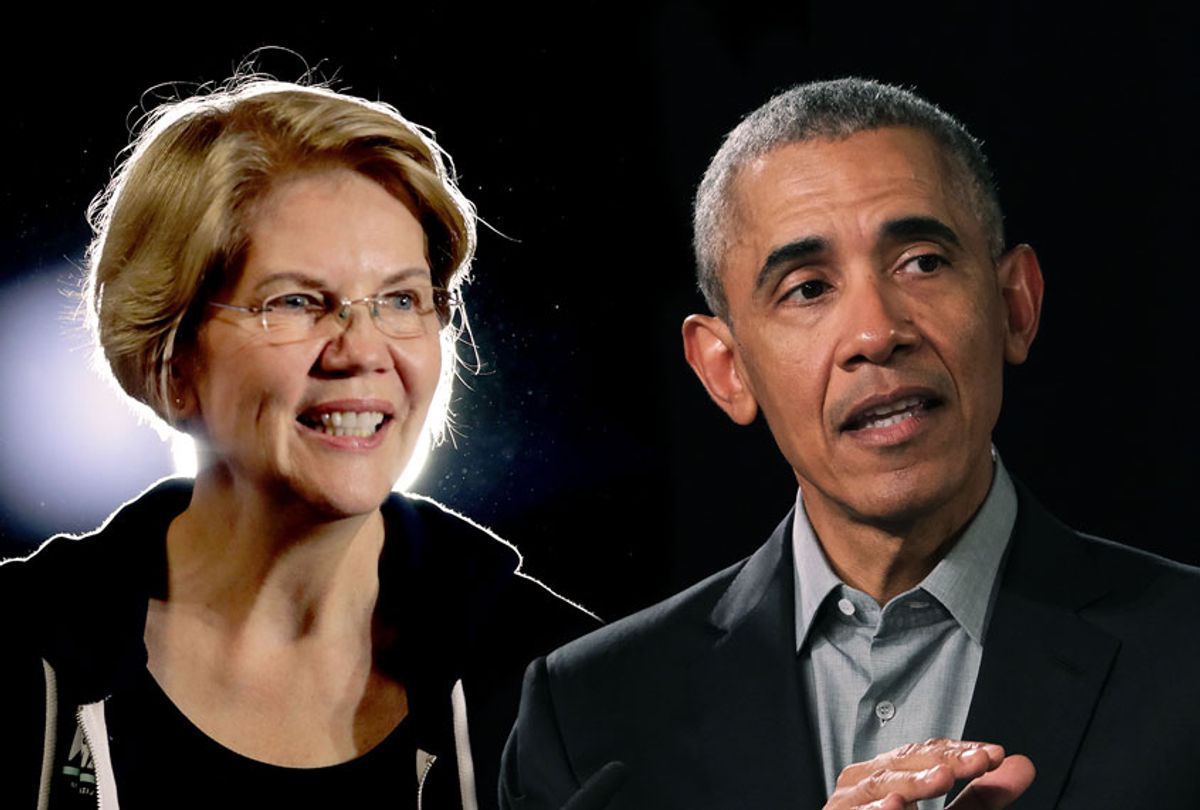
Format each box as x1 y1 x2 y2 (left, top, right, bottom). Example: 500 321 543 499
792 456 1016 810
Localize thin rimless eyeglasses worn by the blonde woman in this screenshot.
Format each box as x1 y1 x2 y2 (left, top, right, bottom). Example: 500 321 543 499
209 287 458 343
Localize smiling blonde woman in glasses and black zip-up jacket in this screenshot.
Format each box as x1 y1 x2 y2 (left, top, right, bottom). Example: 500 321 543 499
0 79 593 810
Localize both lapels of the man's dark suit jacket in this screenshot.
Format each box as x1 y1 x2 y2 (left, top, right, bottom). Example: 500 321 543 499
709 482 1120 806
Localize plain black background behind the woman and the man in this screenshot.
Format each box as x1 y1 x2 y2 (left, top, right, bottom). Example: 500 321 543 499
0 2 1200 618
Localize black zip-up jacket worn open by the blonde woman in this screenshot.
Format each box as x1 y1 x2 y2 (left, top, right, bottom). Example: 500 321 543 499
0 479 598 810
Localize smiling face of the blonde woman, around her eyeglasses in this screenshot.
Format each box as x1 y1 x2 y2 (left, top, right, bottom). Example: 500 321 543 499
177 168 442 517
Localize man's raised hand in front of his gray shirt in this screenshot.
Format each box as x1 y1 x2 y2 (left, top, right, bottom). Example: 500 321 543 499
824 739 1034 810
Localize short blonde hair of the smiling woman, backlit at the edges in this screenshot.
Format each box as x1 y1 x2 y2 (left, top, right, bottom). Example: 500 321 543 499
84 77 476 433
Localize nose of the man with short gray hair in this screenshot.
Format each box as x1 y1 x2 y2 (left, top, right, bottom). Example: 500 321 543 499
838 277 920 370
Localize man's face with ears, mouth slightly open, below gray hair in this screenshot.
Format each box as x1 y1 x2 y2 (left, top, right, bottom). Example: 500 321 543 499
685 127 1040 528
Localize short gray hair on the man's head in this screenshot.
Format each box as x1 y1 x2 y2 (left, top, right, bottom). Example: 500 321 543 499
692 78 1004 320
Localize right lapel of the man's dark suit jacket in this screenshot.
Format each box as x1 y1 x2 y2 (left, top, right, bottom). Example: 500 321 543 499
964 487 1118 806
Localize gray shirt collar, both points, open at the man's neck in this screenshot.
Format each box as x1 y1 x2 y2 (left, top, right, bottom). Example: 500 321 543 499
792 450 1016 652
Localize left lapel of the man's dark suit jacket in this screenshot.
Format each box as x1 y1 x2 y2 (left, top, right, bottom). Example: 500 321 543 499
701 515 826 809
